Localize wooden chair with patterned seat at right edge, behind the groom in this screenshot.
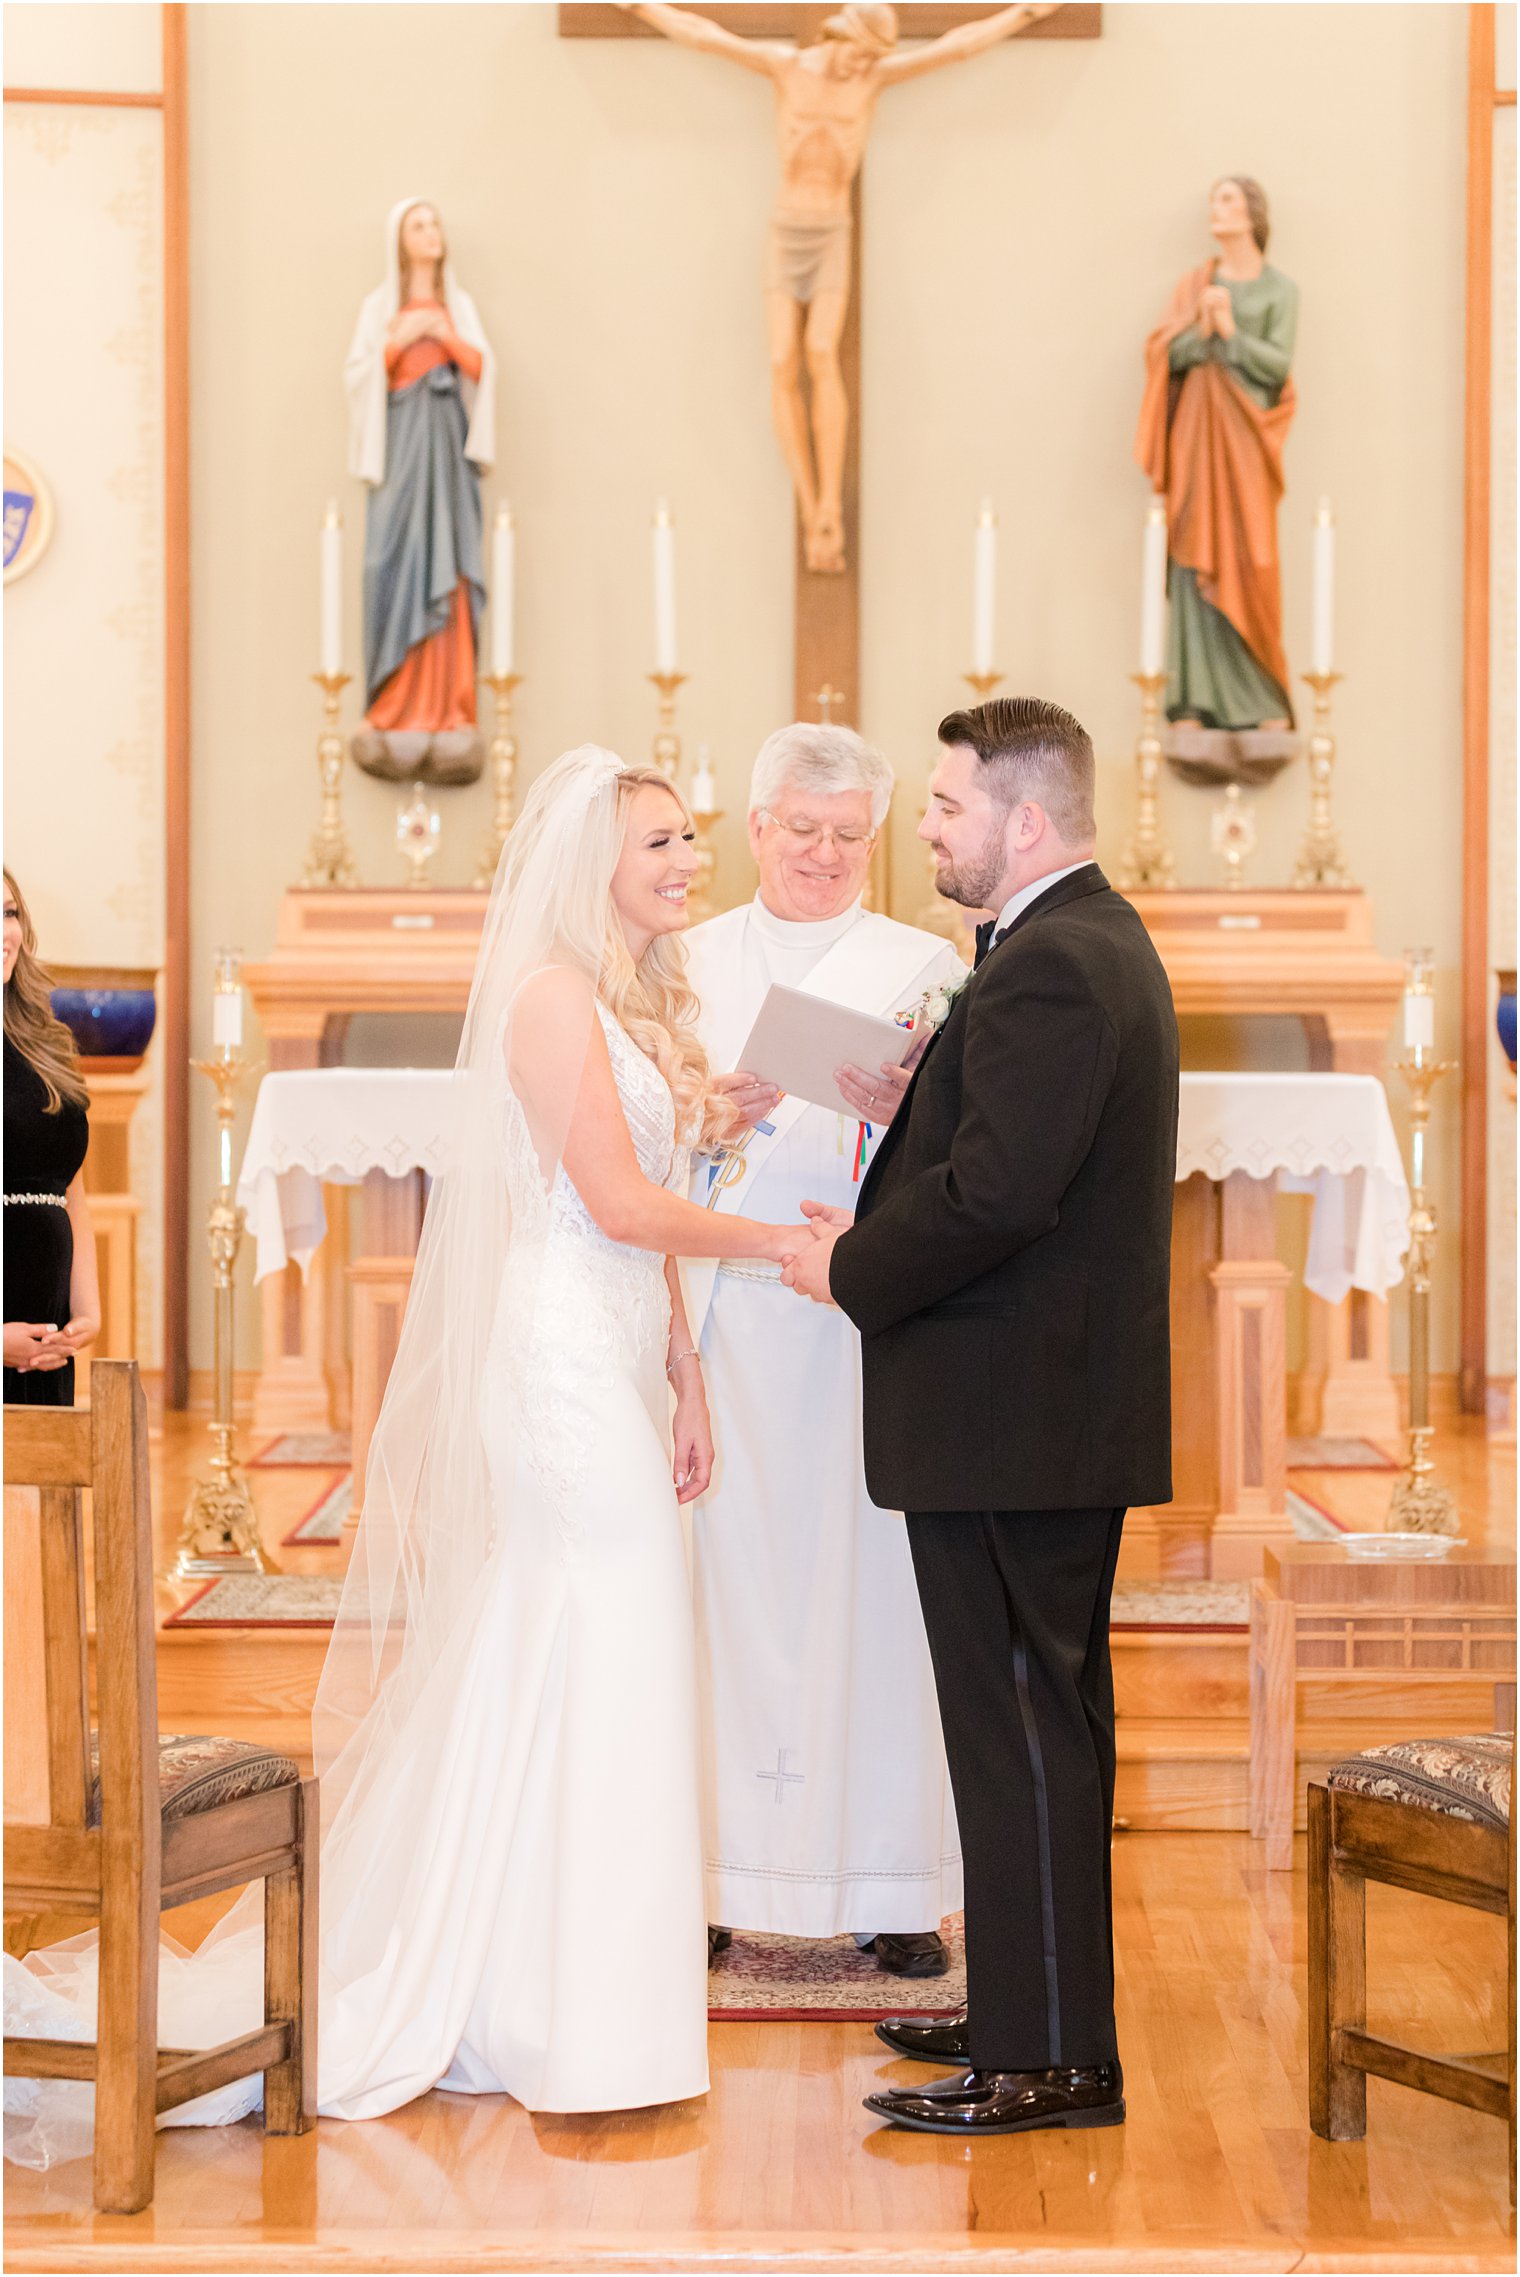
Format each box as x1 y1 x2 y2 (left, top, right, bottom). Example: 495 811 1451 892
1308 1733 1515 2202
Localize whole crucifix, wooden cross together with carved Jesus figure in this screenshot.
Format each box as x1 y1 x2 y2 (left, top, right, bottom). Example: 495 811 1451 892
560 0 1101 722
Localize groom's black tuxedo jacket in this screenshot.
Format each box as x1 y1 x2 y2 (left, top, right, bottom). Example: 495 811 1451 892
831 863 1176 1510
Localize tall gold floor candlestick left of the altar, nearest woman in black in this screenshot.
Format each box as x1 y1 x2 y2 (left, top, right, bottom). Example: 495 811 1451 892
171 952 278 1580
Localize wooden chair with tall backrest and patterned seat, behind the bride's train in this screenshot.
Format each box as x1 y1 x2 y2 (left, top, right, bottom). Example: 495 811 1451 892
5 1359 316 2213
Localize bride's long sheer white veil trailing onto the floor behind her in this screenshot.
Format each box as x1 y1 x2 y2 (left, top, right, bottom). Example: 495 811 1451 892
5 745 626 2165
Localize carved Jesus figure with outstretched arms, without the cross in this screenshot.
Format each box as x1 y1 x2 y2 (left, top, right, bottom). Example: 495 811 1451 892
626 0 1054 569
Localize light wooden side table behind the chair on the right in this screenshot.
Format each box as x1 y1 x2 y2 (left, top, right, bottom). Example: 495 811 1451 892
1249 1542 1515 1874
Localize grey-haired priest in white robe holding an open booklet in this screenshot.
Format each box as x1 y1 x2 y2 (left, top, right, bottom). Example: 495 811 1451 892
685 724 965 1976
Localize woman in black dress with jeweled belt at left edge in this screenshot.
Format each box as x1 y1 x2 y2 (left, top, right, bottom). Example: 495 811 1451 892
5 870 100 1407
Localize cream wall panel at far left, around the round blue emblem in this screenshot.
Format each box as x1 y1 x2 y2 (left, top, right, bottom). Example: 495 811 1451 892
5 93 164 1362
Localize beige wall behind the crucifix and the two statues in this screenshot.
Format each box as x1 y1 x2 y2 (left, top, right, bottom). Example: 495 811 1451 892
7 5 1492 1368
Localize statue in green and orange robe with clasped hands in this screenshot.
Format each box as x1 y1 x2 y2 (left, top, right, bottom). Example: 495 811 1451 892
1135 175 1299 772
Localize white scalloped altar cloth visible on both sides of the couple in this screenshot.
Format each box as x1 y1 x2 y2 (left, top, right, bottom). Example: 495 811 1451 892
237 1068 1409 1305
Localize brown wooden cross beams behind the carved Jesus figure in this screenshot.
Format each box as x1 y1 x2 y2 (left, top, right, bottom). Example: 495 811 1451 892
560 0 1104 726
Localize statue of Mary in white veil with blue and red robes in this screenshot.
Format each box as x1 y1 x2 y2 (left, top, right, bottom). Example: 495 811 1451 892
344 198 496 783
